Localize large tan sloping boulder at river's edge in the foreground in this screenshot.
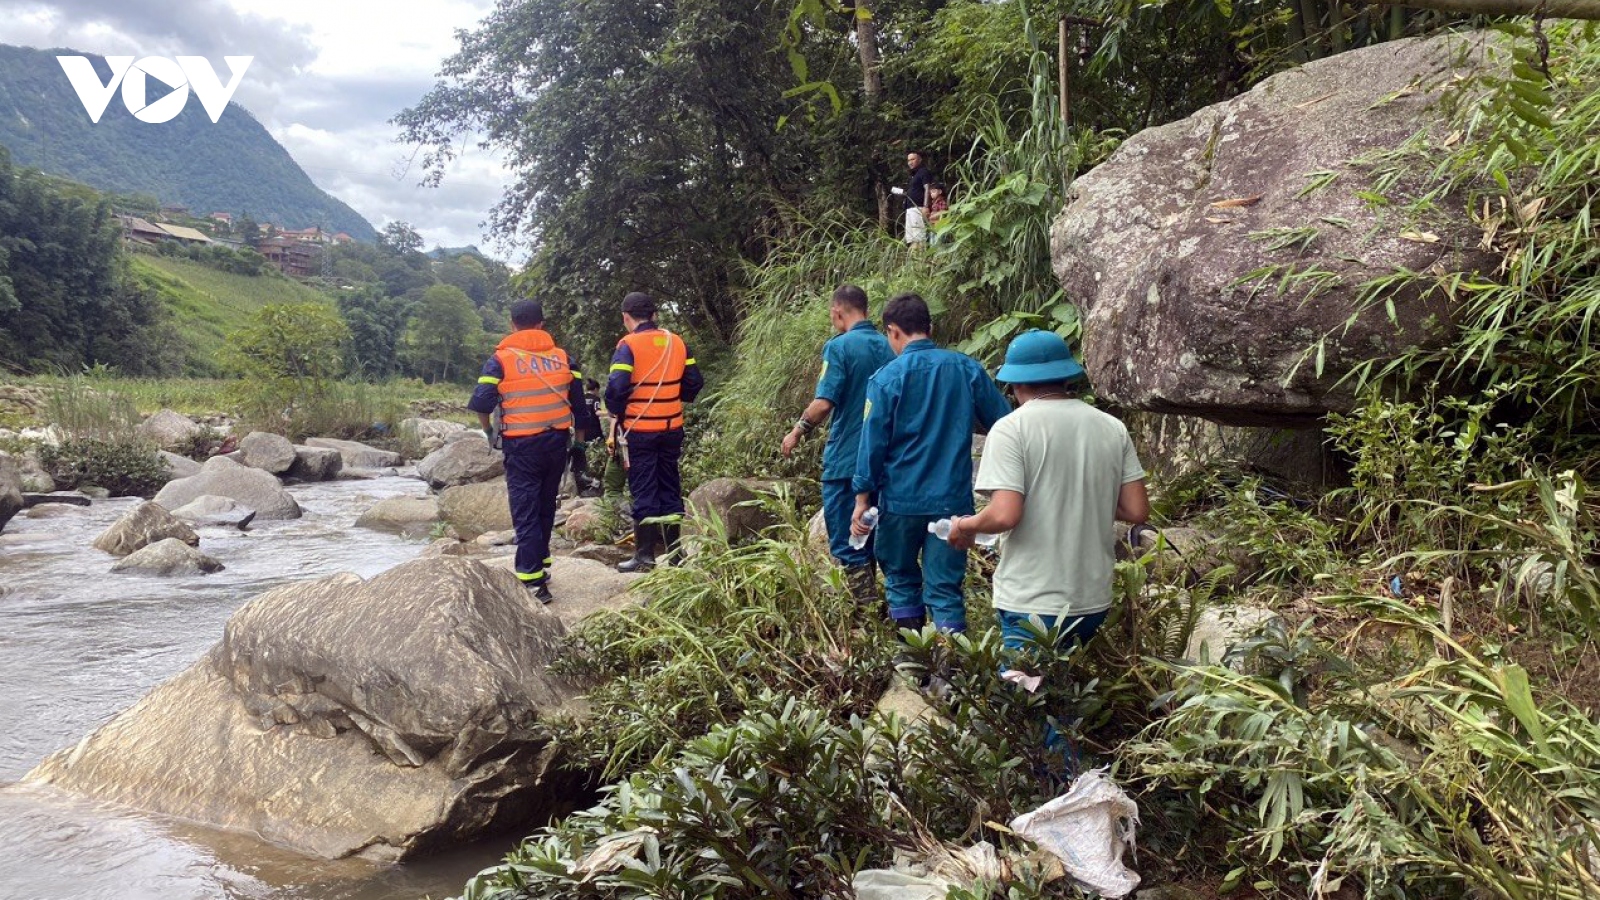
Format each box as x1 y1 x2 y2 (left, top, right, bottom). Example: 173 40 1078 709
26 557 582 860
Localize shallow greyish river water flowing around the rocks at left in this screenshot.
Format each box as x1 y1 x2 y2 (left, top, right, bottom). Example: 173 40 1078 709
0 477 512 900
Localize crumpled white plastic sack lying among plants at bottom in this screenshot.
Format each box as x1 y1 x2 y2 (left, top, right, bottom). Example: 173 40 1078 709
1011 769 1139 897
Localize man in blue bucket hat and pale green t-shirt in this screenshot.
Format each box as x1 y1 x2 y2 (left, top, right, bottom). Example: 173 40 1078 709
950 330 1150 647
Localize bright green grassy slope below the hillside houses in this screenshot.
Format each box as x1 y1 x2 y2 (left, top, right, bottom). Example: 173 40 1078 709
128 253 333 375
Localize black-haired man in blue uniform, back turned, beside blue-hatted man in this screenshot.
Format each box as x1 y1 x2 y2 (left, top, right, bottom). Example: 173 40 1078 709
851 293 1011 631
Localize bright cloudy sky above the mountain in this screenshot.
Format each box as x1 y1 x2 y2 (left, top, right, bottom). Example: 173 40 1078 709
0 0 522 259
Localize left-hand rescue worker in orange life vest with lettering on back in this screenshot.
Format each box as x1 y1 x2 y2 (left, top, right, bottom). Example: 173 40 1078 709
467 299 584 604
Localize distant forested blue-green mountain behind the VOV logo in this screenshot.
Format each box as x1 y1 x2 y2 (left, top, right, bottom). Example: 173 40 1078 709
0 45 378 242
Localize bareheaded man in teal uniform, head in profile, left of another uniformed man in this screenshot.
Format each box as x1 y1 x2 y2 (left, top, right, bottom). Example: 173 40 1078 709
782 285 894 607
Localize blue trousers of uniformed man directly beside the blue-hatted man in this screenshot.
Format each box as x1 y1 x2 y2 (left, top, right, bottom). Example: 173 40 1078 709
874 512 966 631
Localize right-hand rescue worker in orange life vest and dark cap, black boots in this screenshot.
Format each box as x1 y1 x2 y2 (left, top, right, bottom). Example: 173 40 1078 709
605 291 706 572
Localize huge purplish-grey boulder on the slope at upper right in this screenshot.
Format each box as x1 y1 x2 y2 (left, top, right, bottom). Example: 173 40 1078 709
1051 35 1493 426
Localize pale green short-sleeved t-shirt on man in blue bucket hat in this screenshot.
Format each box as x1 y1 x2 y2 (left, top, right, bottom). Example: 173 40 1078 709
976 399 1144 617
